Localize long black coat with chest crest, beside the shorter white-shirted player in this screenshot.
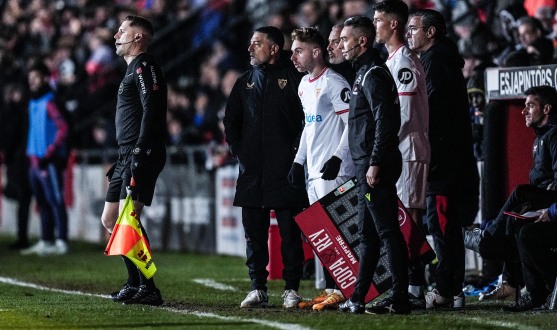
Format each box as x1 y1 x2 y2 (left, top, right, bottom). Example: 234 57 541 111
224 52 309 208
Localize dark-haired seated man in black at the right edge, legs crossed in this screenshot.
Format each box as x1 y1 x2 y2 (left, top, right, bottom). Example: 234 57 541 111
464 86 557 300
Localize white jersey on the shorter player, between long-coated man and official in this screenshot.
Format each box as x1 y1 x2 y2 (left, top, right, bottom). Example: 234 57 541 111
294 68 355 180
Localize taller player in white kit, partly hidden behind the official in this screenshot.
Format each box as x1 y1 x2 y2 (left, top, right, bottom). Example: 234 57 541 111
373 0 431 308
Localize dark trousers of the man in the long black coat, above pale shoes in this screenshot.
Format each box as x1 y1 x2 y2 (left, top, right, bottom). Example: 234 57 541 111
242 207 304 291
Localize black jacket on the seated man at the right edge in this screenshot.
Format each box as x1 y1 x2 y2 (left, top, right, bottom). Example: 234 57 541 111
530 115 557 190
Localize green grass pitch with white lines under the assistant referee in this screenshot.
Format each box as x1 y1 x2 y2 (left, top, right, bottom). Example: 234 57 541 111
0 236 557 330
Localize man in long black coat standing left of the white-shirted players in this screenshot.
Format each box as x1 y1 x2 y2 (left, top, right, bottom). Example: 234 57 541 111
224 26 309 307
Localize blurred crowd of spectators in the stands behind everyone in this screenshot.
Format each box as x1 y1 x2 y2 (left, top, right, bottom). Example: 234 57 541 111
0 0 556 159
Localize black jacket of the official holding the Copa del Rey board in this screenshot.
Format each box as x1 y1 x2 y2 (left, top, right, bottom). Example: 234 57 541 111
348 49 402 183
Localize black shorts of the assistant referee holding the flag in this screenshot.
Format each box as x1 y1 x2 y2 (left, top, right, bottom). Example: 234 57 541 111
105 143 166 206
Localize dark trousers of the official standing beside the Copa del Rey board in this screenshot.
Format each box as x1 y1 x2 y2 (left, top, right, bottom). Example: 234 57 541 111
350 164 408 304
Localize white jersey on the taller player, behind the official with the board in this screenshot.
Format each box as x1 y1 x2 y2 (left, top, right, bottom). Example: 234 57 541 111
386 45 430 163
